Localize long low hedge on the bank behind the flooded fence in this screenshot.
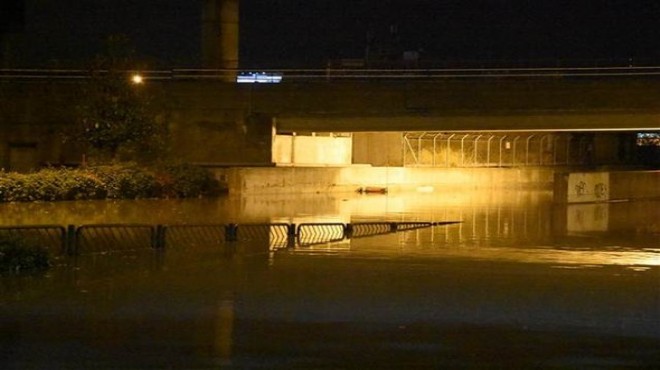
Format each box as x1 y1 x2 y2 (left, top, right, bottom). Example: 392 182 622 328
0 164 222 202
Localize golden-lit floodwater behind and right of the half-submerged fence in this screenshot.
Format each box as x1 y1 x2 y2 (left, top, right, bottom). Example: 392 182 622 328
0 191 660 266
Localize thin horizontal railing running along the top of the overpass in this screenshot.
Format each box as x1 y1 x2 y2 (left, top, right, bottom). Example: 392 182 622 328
0 66 660 83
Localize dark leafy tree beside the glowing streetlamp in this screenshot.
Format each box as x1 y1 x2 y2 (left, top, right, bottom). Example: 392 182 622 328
68 36 167 161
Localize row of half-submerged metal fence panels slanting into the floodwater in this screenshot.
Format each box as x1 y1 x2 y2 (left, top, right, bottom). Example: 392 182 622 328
0 221 460 255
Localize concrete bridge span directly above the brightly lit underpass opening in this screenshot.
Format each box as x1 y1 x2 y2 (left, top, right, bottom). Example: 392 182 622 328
249 75 660 132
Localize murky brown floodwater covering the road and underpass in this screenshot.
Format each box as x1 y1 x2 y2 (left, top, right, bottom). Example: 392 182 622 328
0 191 660 369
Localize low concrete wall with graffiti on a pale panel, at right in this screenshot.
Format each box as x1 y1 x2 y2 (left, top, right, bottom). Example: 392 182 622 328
554 171 660 203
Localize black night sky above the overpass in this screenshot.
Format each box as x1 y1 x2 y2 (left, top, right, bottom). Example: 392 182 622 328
0 0 660 68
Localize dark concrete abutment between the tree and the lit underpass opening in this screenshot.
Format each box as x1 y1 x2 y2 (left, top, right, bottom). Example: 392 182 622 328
166 81 273 165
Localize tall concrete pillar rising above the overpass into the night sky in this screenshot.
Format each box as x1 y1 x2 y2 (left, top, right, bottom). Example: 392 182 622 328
202 0 239 69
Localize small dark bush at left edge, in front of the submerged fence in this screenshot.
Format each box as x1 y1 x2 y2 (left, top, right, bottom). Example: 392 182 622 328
0 236 50 273
